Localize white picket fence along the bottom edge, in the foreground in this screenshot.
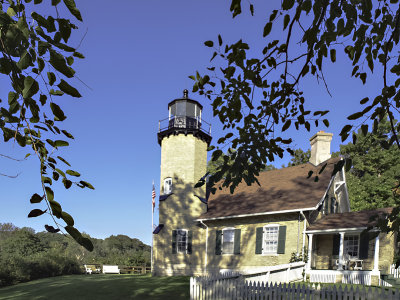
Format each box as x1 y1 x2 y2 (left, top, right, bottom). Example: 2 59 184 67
190 277 400 300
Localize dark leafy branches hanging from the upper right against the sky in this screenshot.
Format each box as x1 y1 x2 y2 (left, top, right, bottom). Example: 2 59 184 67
190 0 400 199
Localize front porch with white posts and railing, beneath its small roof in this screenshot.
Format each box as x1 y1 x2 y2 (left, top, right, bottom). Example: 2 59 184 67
306 227 386 285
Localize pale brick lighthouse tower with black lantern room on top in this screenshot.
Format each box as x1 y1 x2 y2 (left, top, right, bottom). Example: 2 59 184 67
153 90 211 276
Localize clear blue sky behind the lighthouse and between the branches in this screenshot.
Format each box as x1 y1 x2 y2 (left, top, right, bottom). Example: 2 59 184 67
0 0 381 244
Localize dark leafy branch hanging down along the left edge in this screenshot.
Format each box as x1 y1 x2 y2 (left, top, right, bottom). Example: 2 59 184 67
0 0 93 250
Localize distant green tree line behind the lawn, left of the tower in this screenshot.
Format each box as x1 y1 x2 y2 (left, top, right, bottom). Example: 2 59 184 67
0 223 150 287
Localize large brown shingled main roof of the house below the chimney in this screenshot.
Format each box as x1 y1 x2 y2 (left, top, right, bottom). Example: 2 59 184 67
199 158 340 219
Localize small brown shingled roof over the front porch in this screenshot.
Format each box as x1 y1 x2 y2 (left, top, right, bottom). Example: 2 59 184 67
307 207 393 231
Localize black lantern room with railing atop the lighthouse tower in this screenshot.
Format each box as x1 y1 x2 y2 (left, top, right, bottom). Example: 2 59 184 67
158 90 211 145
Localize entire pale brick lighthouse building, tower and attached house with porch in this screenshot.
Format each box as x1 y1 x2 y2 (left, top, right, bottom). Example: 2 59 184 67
153 92 396 280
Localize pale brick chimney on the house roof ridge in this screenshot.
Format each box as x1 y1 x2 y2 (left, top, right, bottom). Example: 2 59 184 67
310 130 333 166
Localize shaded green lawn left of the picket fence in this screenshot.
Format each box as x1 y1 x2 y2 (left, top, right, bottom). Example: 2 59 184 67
0 274 189 300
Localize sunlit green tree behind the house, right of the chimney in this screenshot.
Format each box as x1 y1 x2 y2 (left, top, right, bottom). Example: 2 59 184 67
340 118 400 210
